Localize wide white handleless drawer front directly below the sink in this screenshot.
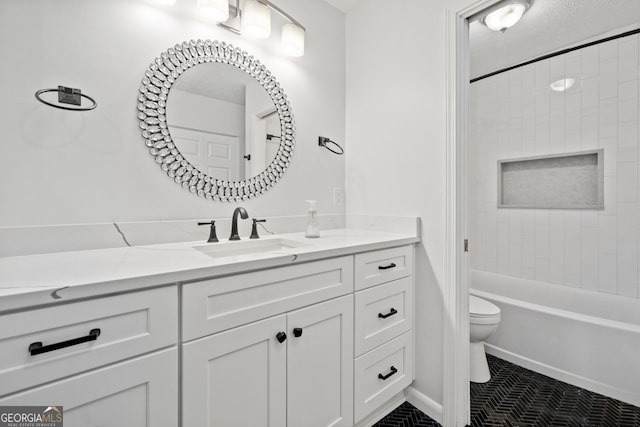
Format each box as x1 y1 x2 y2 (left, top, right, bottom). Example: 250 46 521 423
182 256 353 341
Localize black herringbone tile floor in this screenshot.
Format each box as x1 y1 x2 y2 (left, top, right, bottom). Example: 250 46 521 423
374 356 640 427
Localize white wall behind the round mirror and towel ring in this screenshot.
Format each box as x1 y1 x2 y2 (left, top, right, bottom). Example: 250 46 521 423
0 0 345 226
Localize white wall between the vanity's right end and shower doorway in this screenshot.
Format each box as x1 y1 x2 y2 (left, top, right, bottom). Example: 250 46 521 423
346 0 472 412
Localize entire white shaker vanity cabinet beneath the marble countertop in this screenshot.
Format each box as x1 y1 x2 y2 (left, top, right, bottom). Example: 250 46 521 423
0 237 414 427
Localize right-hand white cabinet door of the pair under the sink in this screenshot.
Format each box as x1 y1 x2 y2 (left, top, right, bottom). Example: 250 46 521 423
287 295 353 427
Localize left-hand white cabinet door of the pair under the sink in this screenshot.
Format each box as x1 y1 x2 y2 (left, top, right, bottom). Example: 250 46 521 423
182 315 289 427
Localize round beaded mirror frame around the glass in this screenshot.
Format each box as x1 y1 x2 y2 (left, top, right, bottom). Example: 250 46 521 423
138 40 295 202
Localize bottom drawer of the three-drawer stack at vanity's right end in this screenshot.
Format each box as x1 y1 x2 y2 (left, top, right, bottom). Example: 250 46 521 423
354 332 413 423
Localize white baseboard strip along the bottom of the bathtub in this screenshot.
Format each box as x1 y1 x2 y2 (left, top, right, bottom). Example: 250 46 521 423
488 342 640 406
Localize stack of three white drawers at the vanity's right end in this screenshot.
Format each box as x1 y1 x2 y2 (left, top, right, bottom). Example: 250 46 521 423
354 246 414 423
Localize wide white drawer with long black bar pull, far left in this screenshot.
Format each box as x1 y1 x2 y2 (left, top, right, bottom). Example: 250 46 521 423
0 286 178 396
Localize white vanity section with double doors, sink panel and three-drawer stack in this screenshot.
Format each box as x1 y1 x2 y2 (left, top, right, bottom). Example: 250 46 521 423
182 245 414 427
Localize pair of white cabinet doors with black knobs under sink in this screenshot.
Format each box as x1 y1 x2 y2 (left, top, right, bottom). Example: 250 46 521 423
182 295 353 427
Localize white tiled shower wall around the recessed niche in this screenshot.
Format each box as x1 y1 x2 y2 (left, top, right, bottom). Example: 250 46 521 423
469 28 640 298
